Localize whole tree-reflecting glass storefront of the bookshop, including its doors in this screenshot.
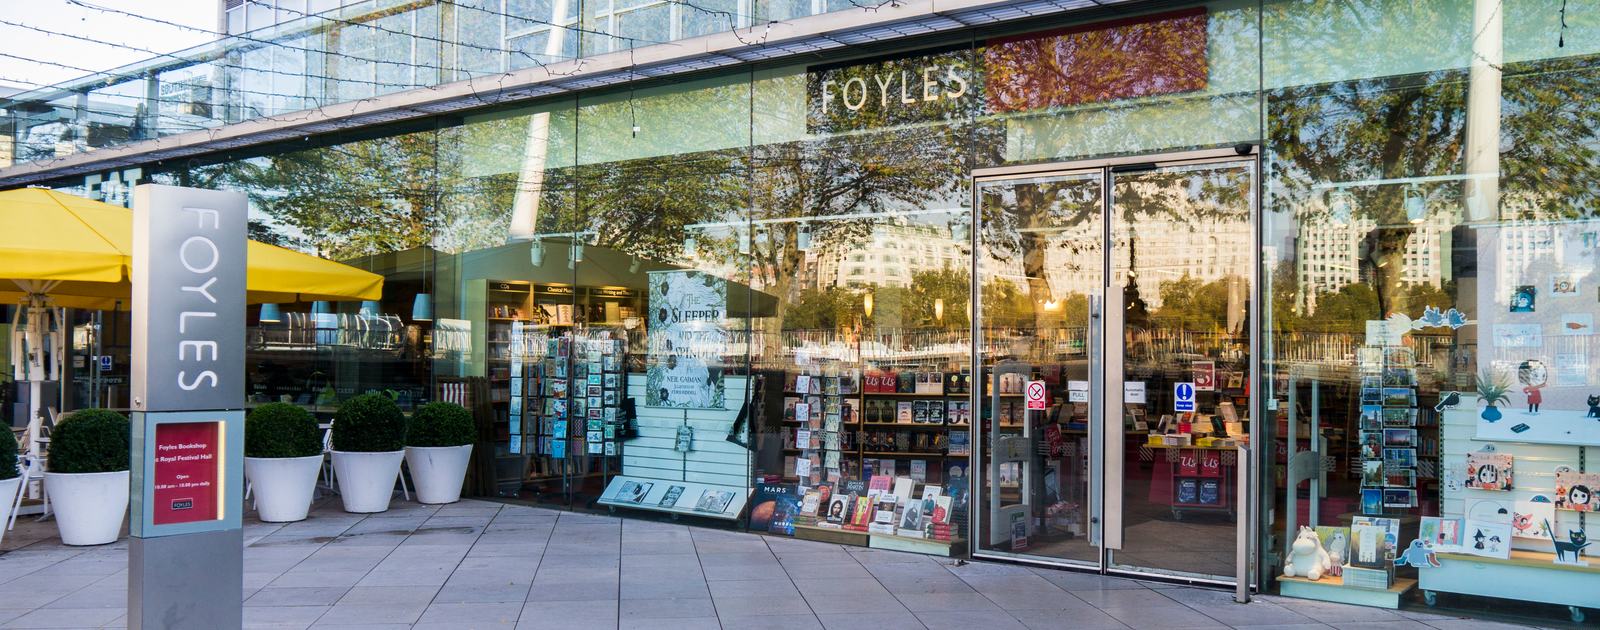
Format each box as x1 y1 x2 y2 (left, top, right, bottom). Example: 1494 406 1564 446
12 0 1600 617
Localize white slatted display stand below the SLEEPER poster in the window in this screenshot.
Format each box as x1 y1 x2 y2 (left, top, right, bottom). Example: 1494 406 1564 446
598 374 750 520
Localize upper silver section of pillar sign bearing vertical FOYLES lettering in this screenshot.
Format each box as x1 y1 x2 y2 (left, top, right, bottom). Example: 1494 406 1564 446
131 184 246 411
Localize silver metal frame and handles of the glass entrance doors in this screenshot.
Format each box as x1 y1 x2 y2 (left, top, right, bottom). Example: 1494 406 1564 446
968 146 1262 601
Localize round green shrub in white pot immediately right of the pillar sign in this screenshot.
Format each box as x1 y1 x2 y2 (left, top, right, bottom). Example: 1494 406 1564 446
245 403 322 523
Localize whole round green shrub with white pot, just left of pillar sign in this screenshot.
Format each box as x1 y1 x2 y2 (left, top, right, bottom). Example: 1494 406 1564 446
45 409 130 545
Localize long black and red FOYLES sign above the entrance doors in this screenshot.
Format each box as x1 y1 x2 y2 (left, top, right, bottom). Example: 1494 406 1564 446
806 8 1210 133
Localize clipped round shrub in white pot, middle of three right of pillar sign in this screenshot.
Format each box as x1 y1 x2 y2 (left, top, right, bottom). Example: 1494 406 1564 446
333 393 405 513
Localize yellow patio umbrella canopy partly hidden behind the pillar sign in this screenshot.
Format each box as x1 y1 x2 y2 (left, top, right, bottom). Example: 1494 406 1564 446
0 189 384 310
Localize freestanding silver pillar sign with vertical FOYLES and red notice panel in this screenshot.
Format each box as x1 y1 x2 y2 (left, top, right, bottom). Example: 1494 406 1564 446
128 184 246 628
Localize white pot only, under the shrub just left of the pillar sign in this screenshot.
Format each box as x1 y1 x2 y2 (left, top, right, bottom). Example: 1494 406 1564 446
45 470 128 545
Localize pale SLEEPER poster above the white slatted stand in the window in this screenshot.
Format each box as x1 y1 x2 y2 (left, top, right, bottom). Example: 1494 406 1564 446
645 270 728 409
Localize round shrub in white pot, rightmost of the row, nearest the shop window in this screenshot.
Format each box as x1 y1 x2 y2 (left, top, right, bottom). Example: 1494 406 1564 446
405 403 477 504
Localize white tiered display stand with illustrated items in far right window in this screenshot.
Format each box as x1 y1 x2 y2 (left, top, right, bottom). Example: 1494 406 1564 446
1418 393 1600 622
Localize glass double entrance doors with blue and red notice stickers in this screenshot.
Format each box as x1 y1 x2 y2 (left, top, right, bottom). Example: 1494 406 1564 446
971 150 1259 584
